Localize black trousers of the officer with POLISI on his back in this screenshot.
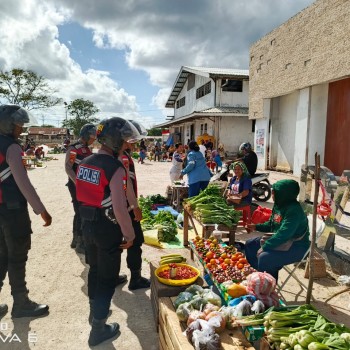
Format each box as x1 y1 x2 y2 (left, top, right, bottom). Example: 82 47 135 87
82 209 123 320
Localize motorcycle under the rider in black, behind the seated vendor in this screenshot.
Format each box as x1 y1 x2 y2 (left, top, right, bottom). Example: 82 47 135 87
210 164 272 202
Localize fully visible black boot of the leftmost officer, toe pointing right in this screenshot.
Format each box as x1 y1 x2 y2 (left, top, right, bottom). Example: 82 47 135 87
11 293 49 318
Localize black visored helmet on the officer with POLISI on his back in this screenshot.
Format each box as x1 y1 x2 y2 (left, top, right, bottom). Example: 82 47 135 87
97 117 141 153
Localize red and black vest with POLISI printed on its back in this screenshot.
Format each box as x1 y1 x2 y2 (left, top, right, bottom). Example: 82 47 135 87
75 154 126 208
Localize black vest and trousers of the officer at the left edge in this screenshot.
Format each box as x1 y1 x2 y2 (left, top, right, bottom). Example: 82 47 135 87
0 135 32 296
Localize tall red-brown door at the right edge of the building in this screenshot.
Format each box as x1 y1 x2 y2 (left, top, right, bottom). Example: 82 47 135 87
324 78 350 175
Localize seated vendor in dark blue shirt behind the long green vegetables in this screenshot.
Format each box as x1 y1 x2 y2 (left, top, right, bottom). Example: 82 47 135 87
226 162 253 209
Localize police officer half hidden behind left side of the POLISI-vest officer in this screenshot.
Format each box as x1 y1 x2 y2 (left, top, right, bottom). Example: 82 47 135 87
65 123 96 254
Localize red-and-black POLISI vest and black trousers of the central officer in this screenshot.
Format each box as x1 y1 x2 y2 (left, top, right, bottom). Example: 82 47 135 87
76 154 123 320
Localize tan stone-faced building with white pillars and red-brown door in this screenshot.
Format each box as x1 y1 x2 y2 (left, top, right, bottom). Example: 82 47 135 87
249 0 350 175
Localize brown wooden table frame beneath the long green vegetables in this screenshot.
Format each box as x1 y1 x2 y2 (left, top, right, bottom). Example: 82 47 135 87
183 207 237 247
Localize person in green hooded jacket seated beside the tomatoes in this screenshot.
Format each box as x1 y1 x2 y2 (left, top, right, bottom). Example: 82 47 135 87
245 180 310 281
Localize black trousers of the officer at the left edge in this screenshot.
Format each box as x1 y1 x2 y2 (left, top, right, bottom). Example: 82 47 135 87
0 204 32 295
